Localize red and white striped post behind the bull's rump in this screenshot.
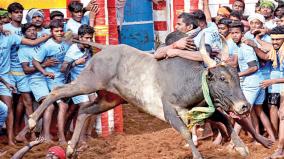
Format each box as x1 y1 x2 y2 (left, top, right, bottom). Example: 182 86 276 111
94 0 123 137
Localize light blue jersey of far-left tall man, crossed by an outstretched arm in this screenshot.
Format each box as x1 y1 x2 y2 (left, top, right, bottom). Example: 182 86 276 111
3 23 23 72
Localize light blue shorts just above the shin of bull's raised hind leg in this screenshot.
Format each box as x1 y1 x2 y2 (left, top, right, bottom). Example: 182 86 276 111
29 77 49 102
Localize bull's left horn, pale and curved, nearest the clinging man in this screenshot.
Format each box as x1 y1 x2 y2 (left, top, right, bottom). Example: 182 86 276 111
199 33 216 68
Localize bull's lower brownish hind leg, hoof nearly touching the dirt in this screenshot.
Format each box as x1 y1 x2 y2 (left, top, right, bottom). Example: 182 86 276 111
66 94 124 158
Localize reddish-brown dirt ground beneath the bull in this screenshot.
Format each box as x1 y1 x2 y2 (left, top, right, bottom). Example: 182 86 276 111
0 105 277 159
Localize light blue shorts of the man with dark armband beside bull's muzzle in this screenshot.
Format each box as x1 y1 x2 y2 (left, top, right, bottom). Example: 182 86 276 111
242 87 265 105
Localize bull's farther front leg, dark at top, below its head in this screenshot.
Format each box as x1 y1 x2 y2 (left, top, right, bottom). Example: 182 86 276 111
210 110 249 156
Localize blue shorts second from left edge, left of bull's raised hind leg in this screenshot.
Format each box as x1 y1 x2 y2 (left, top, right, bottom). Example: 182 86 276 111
10 74 31 93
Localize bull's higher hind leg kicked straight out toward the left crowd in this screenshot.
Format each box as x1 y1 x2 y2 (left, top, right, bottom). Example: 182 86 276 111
28 71 97 129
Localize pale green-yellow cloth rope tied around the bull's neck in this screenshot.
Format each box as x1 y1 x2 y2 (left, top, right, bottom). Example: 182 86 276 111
186 71 215 129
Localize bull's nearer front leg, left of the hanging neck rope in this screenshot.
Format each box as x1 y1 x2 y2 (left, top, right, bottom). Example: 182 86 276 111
162 100 202 159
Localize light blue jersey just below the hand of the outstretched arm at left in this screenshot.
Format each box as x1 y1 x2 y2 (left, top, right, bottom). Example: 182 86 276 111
18 45 44 79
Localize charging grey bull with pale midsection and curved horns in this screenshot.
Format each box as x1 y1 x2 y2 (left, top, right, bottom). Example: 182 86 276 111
28 33 272 159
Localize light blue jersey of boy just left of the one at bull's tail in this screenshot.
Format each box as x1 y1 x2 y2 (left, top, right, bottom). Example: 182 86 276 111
34 39 70 78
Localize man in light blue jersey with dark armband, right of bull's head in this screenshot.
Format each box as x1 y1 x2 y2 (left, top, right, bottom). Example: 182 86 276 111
230 21 275 141
